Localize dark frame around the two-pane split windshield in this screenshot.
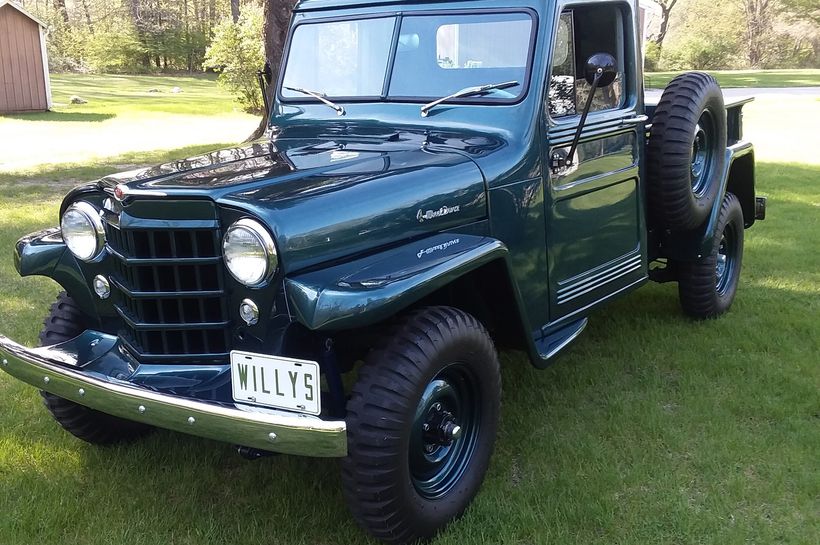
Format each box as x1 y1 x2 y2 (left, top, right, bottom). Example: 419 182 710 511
276 7 539 105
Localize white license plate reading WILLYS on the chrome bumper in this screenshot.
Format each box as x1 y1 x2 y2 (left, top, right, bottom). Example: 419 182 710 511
231 350 322 414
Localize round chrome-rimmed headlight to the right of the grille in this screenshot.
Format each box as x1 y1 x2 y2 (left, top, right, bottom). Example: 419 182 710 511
222 218 279 287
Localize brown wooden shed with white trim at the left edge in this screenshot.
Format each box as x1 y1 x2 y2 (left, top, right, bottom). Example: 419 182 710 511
0 0 51 114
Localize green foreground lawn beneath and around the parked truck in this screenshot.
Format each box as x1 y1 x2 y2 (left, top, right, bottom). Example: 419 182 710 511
0 84 820 545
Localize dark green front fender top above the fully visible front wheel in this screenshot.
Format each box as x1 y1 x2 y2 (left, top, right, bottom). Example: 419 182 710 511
285 233 508 330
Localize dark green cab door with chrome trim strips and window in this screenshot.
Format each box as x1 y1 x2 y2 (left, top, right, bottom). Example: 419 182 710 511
543 2 647 322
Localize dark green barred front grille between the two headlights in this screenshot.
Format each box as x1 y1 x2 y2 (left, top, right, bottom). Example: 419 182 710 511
106 210 230 363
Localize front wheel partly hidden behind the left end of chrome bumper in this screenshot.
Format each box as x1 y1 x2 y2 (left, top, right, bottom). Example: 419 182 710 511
40 292 152 445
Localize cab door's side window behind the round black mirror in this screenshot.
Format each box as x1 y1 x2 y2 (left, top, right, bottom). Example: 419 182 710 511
548 5 626 117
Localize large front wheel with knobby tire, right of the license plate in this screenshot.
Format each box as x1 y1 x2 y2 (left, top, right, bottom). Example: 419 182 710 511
342 307 501 543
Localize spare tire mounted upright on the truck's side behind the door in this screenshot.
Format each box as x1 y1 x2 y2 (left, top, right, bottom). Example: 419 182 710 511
647 72 726 231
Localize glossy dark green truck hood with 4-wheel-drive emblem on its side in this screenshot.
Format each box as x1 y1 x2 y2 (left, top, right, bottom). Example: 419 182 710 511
99 128 491 273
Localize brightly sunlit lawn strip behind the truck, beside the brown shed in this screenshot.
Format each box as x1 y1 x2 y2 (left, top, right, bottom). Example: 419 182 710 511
0 74 258 172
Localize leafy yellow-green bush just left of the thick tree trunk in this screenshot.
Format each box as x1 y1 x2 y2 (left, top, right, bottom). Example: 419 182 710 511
205 4 265 112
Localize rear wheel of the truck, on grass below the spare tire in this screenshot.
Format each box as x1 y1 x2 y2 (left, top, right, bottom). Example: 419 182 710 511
677 193 744 318
